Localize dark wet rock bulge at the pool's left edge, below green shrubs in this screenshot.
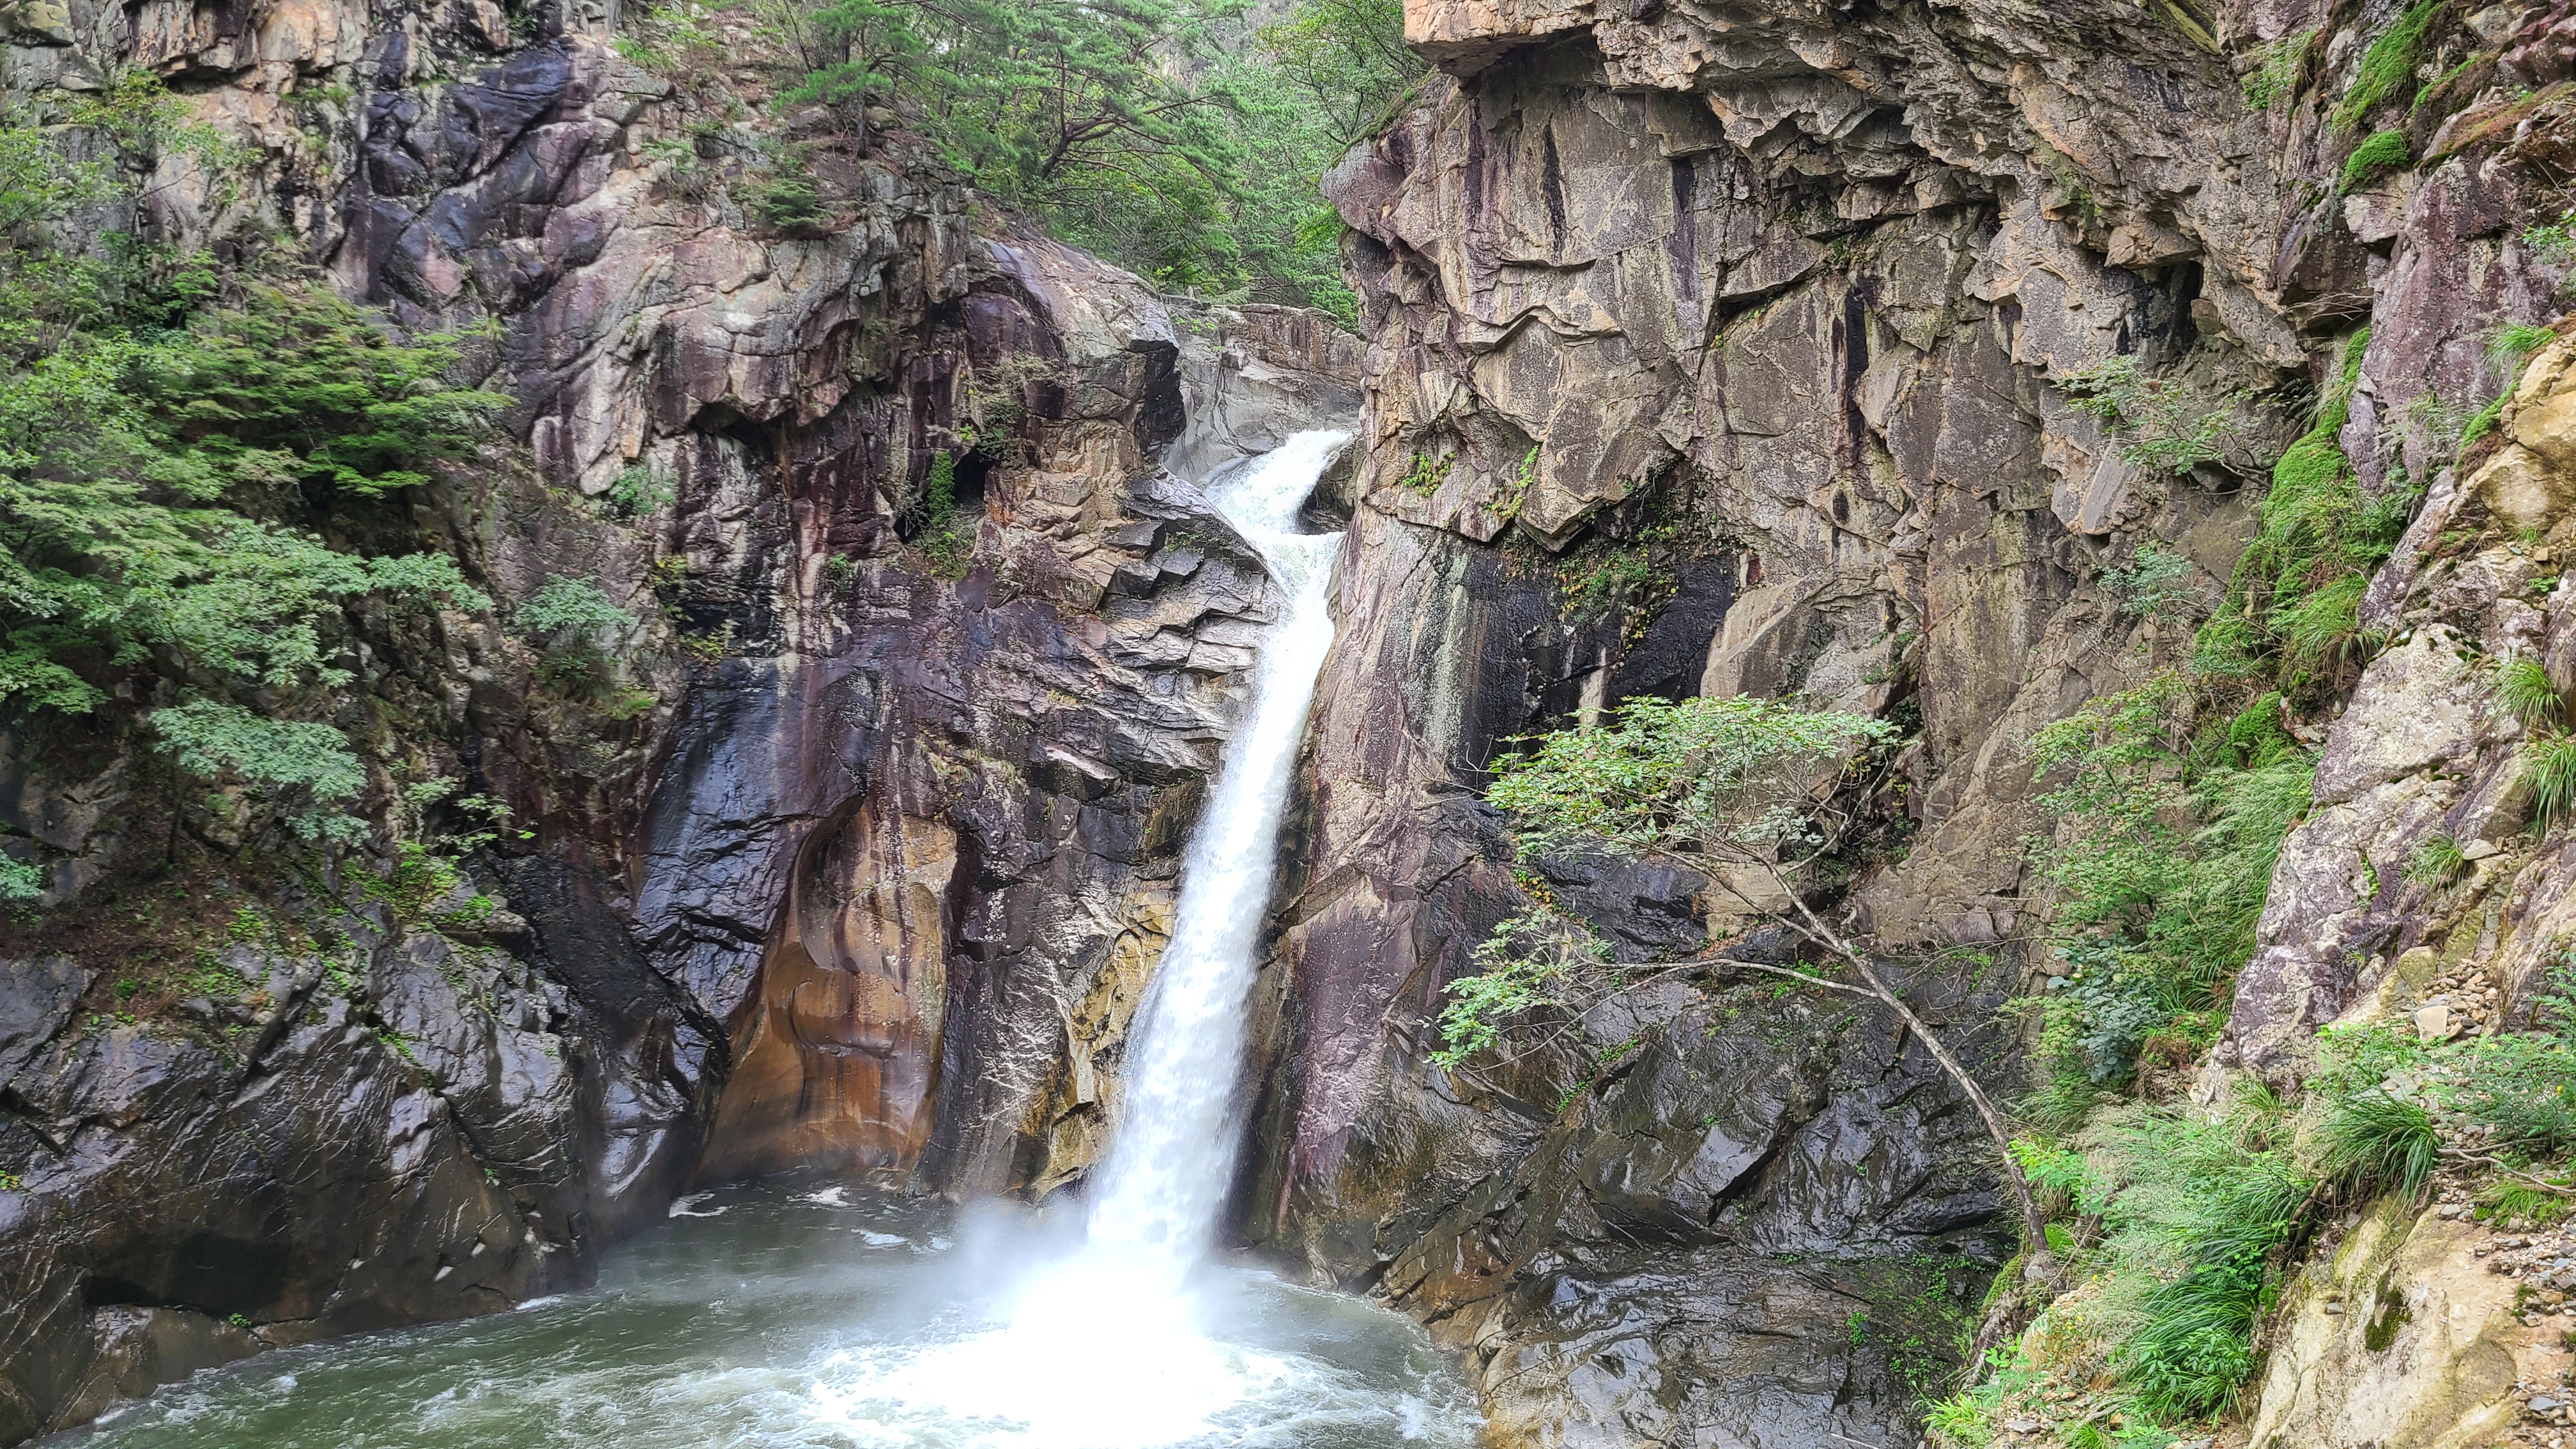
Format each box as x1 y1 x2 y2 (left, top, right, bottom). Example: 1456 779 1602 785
0 918 608 1436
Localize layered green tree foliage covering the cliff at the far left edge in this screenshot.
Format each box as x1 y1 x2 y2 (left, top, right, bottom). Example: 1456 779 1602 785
0 80 497 714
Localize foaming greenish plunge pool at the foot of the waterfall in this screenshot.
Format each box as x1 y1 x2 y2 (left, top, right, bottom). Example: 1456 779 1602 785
65 1186 1476 1449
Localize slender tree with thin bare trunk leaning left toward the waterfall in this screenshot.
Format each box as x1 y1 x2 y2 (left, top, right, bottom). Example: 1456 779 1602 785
1443 696 2056 1274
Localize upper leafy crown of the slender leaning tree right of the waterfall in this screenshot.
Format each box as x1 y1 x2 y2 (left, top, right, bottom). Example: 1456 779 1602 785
1486 696 1896 859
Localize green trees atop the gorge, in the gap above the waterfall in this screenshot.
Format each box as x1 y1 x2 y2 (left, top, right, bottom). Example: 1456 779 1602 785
747 0 1425 305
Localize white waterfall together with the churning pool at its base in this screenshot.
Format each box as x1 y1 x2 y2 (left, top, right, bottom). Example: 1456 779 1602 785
60 433 1476 1449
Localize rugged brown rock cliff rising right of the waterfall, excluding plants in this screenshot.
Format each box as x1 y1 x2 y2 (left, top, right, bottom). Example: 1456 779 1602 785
1241 0 2576 1444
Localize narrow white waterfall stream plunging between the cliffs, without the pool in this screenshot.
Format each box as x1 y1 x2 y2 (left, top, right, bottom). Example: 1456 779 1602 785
1090 431 1350 1279
